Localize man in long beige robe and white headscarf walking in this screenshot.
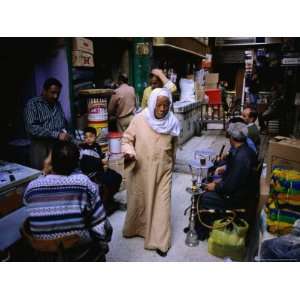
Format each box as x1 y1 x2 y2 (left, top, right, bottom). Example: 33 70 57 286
122 89 180 256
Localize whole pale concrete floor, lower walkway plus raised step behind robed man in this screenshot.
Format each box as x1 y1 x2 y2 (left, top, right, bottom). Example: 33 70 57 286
107 131 225 262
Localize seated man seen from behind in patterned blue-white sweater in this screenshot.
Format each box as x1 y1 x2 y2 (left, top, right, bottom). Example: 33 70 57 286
24 141 112 260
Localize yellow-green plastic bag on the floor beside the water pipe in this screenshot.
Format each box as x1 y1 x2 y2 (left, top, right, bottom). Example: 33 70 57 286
208 218 249 261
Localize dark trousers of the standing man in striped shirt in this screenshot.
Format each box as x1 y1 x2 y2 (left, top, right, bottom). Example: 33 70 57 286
29 139 53 170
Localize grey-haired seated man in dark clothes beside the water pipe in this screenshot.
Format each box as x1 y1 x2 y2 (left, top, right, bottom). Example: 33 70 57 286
196 123 257 239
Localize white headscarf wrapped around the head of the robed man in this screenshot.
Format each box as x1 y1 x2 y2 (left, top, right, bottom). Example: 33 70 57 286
145 88 180 136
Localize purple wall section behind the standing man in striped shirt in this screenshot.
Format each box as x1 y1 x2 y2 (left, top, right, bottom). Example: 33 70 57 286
35 47 71 122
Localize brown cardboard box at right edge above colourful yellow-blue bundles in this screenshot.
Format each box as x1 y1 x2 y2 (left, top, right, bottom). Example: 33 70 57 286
267 136 300 183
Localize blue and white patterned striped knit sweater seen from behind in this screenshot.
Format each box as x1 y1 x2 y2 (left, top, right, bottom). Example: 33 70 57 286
23 174 112 241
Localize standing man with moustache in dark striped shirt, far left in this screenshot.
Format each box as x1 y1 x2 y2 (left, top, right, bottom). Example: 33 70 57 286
24 78 71 170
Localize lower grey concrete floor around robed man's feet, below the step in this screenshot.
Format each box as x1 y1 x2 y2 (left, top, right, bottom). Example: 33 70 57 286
107 173 222 262
